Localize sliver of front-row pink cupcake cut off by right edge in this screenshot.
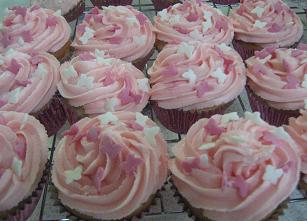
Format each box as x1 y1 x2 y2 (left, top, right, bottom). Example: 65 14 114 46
285 108 307 191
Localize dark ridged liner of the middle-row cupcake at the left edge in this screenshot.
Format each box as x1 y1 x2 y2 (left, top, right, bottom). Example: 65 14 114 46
31 94 67 136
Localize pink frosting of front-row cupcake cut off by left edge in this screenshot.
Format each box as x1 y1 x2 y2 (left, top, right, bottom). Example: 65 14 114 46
0 111 48 212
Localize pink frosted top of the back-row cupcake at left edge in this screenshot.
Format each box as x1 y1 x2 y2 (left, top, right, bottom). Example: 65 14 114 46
0 5 70 53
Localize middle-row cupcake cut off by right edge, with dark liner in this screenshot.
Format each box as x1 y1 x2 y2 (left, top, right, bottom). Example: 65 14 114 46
246 45 307 126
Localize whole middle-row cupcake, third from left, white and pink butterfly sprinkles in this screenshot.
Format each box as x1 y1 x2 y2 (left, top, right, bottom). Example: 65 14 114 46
148 42 246 133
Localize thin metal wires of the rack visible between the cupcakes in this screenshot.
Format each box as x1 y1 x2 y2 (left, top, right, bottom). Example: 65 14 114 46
39 0 307 221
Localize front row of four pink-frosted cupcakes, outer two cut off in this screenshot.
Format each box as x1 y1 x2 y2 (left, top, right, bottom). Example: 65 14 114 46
0 110 307 221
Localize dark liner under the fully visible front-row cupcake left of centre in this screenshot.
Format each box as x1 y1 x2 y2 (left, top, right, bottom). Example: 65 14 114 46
49 185 163 221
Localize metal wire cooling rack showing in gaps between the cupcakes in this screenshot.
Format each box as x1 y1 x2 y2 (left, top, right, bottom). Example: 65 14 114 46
38 0 307 221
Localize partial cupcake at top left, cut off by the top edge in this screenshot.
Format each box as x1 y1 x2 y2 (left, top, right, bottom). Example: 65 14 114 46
33 0 85 22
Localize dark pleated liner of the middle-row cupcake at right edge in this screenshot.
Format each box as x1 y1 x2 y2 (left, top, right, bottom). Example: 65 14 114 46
246 86 300 127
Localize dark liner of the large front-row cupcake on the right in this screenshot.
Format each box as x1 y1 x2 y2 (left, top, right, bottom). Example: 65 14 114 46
170 179 289 221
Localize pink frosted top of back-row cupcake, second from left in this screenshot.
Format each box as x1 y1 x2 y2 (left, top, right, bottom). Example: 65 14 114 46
72 6 155 61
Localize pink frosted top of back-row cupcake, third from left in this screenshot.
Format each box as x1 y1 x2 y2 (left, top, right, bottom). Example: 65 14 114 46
154 0 234 44
